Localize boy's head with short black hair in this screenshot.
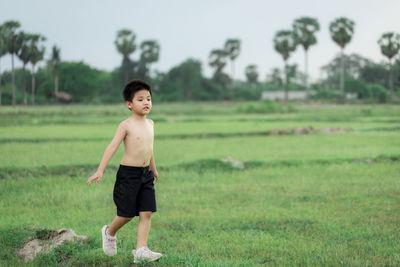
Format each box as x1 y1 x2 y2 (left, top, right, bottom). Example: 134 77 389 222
122 80 151 115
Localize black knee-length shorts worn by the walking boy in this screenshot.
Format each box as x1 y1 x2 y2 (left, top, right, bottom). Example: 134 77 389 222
113 165 156 218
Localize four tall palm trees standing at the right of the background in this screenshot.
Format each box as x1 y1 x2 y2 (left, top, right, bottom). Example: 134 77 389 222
273 17 400 101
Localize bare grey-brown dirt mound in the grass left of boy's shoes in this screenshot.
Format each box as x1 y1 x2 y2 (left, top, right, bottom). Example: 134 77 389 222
18 228 87 262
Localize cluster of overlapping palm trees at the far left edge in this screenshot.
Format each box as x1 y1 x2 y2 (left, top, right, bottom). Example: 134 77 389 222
0 21 60 106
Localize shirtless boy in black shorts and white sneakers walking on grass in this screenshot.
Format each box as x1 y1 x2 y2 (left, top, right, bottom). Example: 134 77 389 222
87 80 162 263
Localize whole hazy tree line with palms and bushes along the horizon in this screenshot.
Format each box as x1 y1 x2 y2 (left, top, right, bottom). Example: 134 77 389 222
0 17 400 105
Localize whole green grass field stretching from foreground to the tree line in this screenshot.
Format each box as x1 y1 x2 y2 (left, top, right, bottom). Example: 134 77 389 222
0 103 400 266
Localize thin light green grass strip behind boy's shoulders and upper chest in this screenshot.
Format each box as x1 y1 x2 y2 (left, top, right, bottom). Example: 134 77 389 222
0 119 394 142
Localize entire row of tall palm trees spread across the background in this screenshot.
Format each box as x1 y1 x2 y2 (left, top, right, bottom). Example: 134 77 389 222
0 17 400 105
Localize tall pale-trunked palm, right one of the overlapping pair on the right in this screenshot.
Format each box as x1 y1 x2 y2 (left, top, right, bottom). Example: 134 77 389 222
293 17 319 98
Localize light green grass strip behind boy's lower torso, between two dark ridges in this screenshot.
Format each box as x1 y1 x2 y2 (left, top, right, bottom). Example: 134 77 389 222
0 132 400 168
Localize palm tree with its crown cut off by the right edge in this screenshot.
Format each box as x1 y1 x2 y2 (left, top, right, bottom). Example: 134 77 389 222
378 32 400 99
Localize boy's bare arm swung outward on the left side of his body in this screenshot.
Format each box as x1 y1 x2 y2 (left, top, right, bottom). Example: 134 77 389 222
86 122 127 185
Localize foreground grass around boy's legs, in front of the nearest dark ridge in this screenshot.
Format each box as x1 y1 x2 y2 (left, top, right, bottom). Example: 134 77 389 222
0 163 400 266
